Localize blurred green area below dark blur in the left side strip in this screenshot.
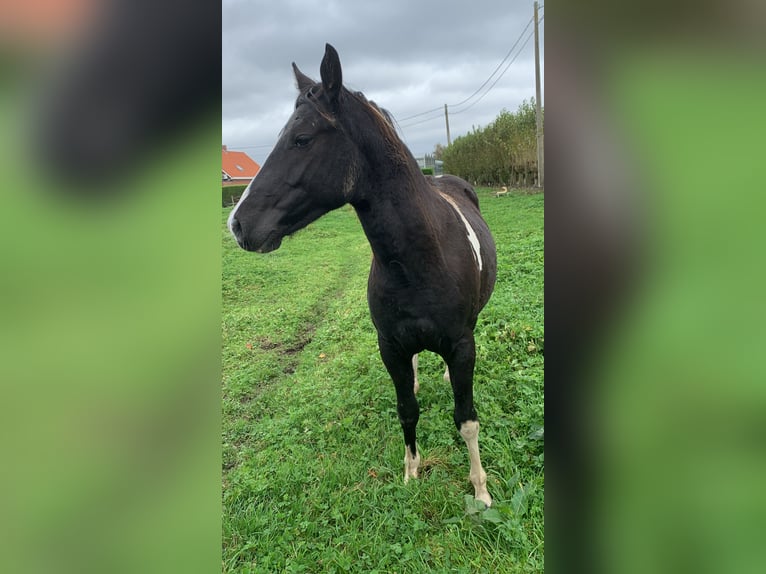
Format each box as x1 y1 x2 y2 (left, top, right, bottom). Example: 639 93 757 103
0 46 220 573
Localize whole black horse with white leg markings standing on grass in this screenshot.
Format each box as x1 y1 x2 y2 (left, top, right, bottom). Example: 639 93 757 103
228 44 497 506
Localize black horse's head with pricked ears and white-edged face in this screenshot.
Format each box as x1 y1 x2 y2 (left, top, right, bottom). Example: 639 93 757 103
228 44 359 253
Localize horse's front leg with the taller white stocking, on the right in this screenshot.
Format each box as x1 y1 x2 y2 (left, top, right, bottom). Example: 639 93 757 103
447 334 492 506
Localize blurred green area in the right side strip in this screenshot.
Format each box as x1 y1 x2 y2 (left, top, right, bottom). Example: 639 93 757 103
594 51 766 573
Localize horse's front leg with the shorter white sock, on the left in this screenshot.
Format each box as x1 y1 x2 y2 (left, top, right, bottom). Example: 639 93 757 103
378 336 420 482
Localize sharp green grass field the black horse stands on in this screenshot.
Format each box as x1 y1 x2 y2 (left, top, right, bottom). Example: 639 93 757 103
222 189 544 573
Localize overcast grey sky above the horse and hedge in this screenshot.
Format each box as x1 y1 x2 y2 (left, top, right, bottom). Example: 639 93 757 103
221 0 545 164
